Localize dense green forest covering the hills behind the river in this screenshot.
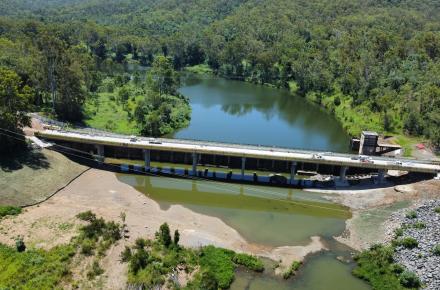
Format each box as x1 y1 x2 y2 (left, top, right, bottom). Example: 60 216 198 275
0 0 440 150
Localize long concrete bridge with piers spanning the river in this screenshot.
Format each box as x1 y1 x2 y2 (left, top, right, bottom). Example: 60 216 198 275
36 130 440 184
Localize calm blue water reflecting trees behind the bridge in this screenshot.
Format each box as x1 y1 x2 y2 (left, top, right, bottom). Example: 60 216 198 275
171 74 349 152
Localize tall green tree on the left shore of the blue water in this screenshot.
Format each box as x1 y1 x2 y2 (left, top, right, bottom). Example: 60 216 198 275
147 56 179 95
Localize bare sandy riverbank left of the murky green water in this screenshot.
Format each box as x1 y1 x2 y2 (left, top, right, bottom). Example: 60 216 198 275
0 169 324 288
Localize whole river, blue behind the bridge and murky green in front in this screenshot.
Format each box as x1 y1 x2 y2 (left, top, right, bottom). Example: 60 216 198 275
118 74 370 290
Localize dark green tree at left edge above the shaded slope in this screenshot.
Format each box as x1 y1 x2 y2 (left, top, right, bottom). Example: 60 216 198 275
0 68 32 153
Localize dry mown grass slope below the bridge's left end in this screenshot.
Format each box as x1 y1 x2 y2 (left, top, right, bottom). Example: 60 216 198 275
0 149 86 206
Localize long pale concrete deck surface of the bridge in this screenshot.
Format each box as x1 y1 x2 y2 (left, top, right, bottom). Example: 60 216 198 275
36 130 440 174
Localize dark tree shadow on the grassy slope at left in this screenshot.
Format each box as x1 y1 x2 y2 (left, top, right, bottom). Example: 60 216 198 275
0 149 50 172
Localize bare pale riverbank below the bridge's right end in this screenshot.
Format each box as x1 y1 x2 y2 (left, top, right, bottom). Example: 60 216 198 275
306 180 440 251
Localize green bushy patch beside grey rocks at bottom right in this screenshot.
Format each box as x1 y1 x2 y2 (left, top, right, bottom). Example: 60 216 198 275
353 245 419 290
